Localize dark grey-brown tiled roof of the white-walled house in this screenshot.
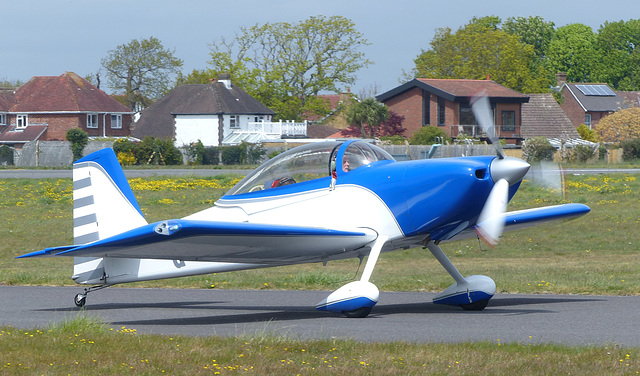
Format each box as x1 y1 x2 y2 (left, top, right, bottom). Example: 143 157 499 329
133 82 275 138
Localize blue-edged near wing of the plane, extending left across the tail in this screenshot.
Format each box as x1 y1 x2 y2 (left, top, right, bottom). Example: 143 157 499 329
18 219 378 264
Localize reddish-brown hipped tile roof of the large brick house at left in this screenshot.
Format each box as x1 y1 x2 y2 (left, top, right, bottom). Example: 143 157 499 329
11 72 132 113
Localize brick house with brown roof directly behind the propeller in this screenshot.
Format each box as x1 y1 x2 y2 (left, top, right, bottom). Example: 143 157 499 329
376 78 529 144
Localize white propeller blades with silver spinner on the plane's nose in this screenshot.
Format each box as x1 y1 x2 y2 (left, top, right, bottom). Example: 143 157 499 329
471 92 530 246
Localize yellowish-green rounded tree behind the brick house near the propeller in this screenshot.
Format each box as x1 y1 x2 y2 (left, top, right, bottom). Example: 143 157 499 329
412 19 549 93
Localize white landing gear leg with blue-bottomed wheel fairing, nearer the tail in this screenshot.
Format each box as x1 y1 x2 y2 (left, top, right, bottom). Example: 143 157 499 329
316 236 388 318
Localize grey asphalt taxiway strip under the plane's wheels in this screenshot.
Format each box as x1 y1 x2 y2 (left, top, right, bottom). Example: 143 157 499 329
0 286 640 347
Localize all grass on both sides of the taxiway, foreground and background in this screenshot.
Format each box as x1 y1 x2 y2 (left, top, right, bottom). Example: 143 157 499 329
0 175 640 375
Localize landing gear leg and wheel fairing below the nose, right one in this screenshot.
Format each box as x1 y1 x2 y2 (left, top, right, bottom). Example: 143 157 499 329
427 240 496 311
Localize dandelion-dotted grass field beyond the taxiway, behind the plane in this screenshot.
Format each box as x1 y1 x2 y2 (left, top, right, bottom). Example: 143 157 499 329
0 170 640 295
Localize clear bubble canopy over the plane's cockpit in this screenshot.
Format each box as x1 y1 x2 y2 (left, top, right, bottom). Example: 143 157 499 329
226 141 393 196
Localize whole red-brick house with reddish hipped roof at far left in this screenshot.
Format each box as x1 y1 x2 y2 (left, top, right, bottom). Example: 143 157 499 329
0 72 133 148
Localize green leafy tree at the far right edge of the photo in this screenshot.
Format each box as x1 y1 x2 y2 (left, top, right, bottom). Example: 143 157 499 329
593 20 640 91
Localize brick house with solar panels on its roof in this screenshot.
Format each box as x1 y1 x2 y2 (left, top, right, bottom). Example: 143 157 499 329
560 83 632 129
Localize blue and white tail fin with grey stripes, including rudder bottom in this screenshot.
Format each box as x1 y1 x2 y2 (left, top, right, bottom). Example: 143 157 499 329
73 149 147 284
